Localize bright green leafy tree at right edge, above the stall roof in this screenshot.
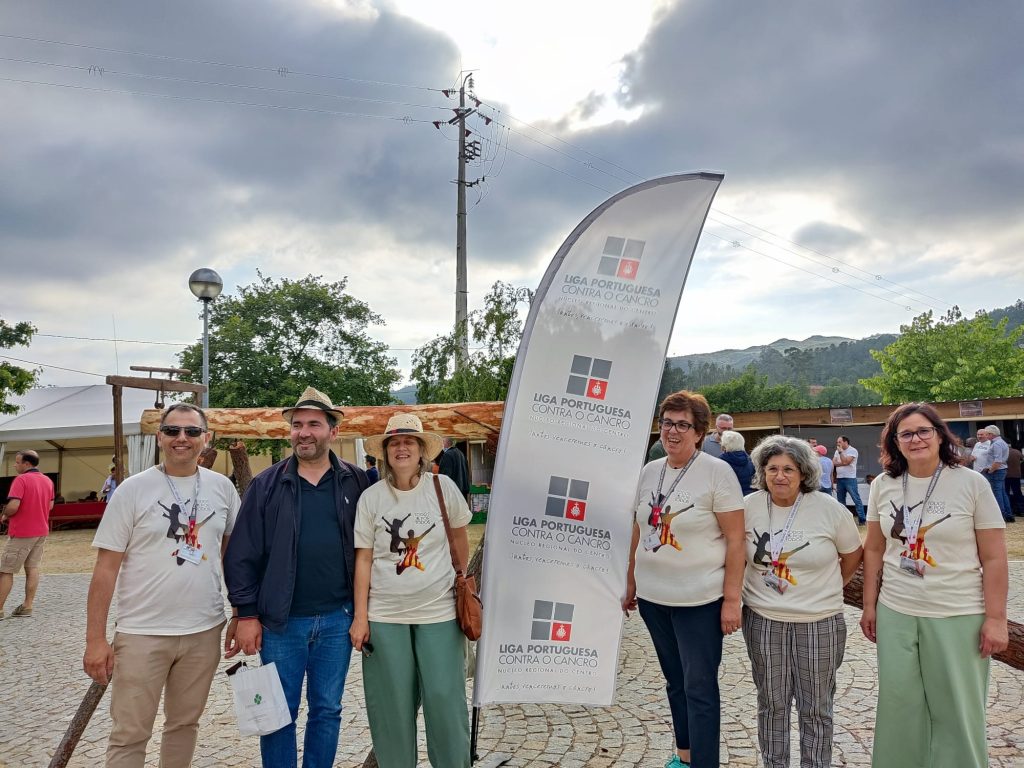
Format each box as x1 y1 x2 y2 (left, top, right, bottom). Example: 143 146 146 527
860 307 1024 403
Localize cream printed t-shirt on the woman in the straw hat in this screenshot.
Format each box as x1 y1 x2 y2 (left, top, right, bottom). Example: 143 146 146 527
355 473 473 624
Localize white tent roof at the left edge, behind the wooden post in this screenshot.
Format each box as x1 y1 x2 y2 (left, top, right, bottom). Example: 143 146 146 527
0 384 163 442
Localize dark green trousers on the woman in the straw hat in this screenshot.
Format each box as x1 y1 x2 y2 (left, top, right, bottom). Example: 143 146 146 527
362 620 470 768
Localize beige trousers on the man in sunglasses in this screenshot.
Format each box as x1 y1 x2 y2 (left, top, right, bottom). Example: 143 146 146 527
106 624 224 768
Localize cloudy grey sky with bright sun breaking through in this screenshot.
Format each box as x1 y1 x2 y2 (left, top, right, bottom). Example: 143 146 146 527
0 0 1024 385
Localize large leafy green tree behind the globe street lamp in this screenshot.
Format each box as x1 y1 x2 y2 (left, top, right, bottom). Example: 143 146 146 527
179 273 400 421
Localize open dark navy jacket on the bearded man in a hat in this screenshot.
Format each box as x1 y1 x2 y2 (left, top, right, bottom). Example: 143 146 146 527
224 452 369 631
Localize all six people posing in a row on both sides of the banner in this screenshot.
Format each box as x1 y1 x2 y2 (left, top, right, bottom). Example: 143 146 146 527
75 388 1007 768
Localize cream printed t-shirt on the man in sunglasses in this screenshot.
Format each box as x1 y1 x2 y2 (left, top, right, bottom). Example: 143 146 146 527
92 467 240 635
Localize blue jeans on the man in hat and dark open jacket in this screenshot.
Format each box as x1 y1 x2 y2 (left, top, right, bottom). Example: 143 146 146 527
259 603 352 768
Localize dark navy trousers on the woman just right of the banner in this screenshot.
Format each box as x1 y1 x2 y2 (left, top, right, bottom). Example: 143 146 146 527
637 598 722 768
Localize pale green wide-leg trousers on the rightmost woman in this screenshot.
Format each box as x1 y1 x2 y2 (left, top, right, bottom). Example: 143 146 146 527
871 603 989 768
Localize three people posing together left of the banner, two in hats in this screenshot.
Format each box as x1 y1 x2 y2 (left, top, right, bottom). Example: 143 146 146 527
83 388 472 768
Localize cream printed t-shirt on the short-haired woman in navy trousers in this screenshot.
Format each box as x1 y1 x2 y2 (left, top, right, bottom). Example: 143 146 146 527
633 452 743 605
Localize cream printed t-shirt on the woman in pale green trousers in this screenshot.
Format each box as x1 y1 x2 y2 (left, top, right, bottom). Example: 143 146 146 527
867 467 1006 618
